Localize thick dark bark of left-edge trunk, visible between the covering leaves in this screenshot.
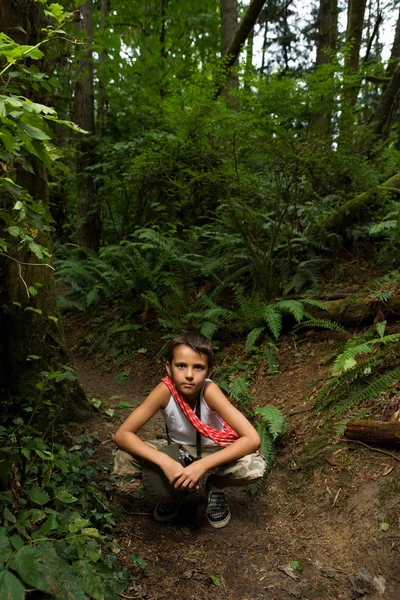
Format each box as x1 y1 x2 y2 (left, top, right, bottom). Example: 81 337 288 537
0 0 89 426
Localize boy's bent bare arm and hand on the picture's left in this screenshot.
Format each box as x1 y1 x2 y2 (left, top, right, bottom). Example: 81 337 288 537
114 383 187 483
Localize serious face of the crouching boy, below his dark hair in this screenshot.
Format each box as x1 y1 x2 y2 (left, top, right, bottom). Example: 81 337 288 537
166 344 210 400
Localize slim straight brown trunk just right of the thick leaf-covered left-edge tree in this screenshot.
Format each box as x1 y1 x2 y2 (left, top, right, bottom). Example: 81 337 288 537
75 0 101 252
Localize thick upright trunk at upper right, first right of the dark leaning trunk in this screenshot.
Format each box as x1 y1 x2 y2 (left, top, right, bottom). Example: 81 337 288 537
310 0 338 138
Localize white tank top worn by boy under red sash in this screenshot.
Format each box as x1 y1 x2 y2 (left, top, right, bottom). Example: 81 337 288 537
161 379 223 446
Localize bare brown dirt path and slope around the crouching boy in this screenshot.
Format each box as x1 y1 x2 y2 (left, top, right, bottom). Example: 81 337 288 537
69 332 400 600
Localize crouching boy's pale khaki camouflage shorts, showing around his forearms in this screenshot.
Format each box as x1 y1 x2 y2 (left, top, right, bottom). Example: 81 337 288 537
114 440 266 480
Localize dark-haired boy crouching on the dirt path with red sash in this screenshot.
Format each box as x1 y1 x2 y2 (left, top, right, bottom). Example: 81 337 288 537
114 332 265 528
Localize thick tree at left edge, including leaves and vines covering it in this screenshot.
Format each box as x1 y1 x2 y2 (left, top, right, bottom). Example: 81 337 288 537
0 0 87 425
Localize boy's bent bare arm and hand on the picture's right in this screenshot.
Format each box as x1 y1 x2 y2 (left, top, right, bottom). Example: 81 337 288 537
175 383 261 489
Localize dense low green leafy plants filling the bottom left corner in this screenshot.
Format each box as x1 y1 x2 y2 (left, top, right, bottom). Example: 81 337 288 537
0 370 127 600
